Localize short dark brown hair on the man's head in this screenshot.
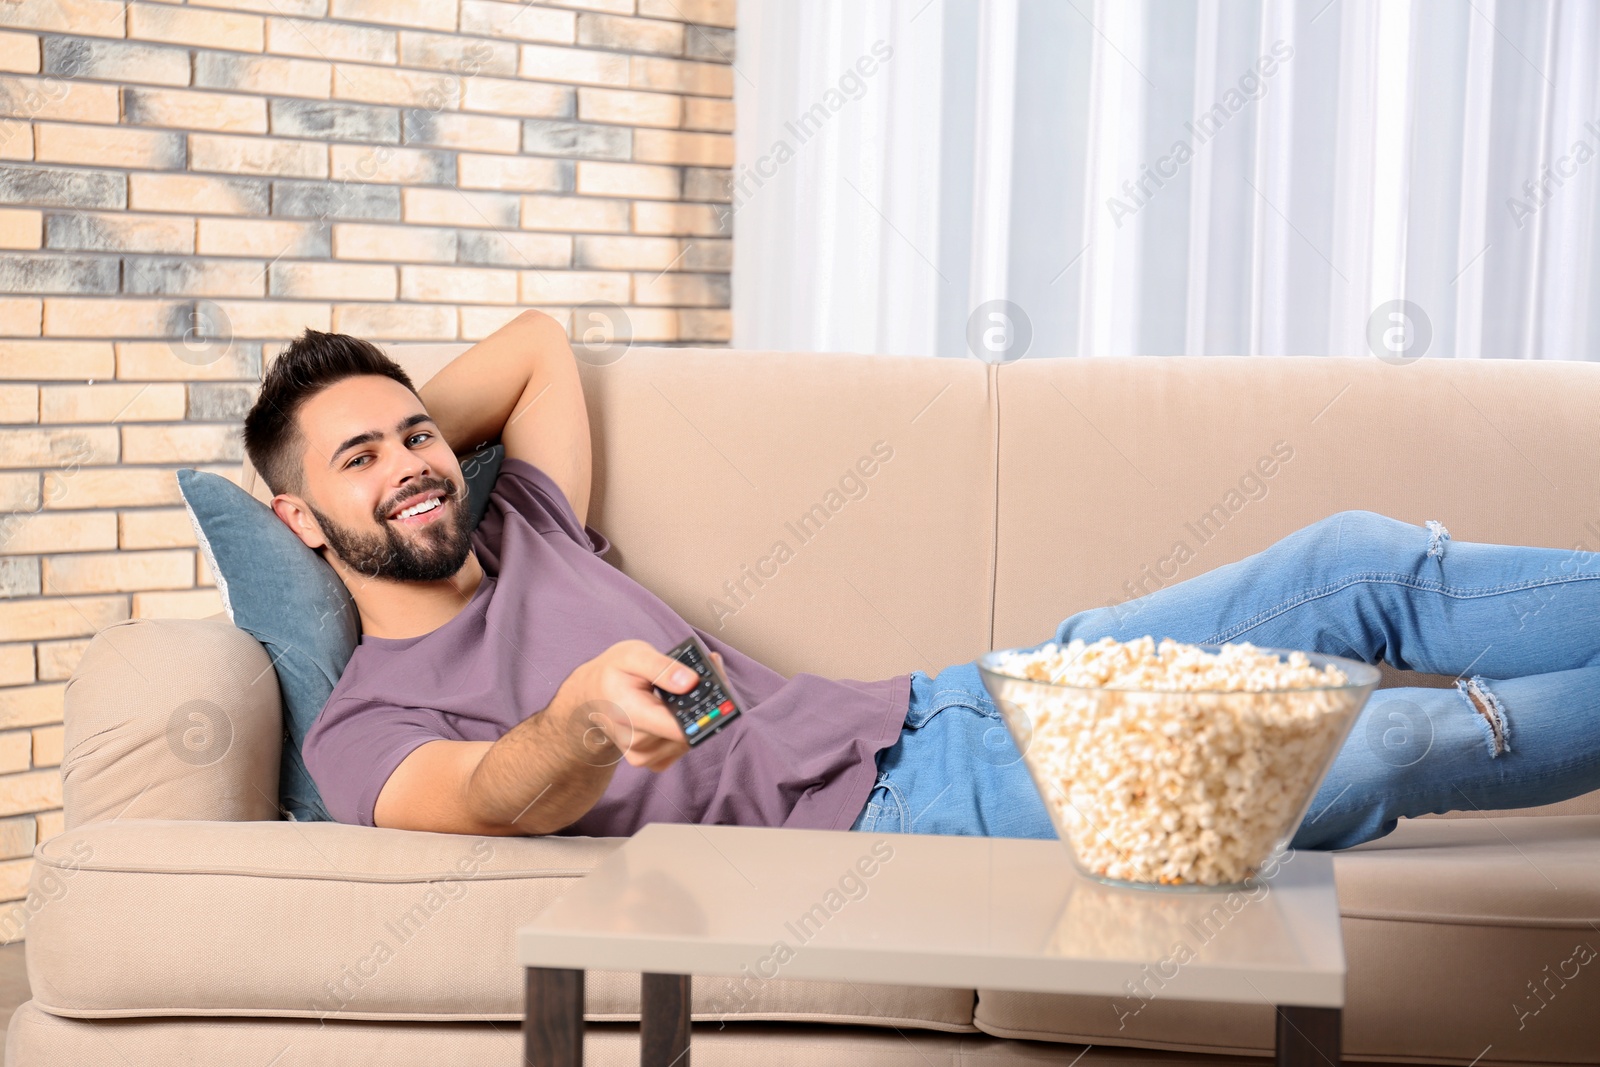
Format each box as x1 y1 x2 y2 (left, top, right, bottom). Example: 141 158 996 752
245 326 421 494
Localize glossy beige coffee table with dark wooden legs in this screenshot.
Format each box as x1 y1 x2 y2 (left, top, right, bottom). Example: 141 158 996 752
517 822 1344 1067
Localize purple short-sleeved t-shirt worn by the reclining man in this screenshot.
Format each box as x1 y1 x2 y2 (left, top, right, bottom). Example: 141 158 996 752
302 459 910 837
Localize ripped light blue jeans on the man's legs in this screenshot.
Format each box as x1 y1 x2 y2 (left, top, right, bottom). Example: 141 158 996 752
851 510 1600 849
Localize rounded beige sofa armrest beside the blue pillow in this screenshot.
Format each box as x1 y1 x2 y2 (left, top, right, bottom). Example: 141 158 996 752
61 616 283 830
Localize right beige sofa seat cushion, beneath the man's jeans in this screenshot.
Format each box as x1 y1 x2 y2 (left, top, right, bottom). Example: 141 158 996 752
973 816 1600 1067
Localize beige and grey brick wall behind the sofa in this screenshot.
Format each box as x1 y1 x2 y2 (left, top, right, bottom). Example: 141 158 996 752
0 0 734 939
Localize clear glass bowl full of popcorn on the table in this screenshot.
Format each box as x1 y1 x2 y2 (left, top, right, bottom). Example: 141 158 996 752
978 635 1379 889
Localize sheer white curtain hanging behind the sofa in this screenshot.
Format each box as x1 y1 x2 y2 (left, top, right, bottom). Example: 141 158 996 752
728 0 1600 362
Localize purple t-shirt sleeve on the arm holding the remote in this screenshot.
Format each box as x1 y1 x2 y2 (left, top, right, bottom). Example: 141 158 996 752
301 697 459 825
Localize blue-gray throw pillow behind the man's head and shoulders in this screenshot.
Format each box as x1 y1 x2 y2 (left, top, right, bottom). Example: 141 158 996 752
178 445 506 822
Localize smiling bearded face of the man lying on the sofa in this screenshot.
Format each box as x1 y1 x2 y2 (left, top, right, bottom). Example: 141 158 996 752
278 374 472 582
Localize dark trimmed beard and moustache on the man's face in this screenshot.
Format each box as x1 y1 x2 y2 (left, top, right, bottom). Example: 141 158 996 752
306 478 472 582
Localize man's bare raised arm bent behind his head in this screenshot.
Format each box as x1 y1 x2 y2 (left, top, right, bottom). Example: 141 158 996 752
418 309 594 522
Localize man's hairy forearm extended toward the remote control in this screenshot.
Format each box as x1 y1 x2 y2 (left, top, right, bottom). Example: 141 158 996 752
467 705 621 833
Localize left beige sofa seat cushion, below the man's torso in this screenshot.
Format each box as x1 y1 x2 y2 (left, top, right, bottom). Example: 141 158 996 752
26 819 974 1033
